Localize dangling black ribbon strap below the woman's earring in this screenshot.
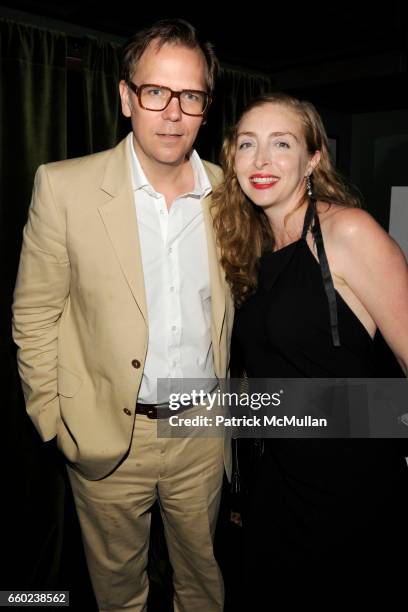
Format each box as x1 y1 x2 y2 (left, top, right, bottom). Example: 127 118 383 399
302 200 340 346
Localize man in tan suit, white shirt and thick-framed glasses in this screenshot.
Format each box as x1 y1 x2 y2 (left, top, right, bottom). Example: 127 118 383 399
13 20 233 612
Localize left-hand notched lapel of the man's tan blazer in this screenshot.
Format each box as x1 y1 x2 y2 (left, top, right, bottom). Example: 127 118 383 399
98 139 147 323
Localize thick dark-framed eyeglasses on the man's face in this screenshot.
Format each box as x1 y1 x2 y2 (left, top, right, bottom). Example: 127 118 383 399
127 81 211 117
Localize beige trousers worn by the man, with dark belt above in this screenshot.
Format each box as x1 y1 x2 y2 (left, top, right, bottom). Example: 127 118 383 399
68 410 224 612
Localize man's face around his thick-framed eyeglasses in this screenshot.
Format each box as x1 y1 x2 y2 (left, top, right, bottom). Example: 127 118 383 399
119 41 207 171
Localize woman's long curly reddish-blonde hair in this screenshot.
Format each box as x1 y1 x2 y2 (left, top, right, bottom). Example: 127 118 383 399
212 93 360 306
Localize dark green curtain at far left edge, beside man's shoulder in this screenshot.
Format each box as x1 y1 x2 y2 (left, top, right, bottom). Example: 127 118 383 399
0 20 67 322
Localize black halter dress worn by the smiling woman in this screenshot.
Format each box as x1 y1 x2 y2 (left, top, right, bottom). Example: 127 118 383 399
232 202 408 610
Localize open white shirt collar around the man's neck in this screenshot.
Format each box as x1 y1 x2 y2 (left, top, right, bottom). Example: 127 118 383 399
127 132 212 199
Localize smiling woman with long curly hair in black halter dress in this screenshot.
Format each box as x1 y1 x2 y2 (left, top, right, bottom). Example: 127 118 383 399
214 94 408 610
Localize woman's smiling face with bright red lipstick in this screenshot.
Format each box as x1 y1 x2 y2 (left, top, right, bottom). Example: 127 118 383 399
235 103 318 210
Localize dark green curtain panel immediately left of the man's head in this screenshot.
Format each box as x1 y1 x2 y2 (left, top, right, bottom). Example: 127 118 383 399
82 37 131 153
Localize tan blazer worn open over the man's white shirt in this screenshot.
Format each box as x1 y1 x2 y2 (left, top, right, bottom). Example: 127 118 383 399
13 140 233 480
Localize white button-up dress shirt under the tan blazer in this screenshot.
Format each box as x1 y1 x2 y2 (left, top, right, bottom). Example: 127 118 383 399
128 133 215 404
